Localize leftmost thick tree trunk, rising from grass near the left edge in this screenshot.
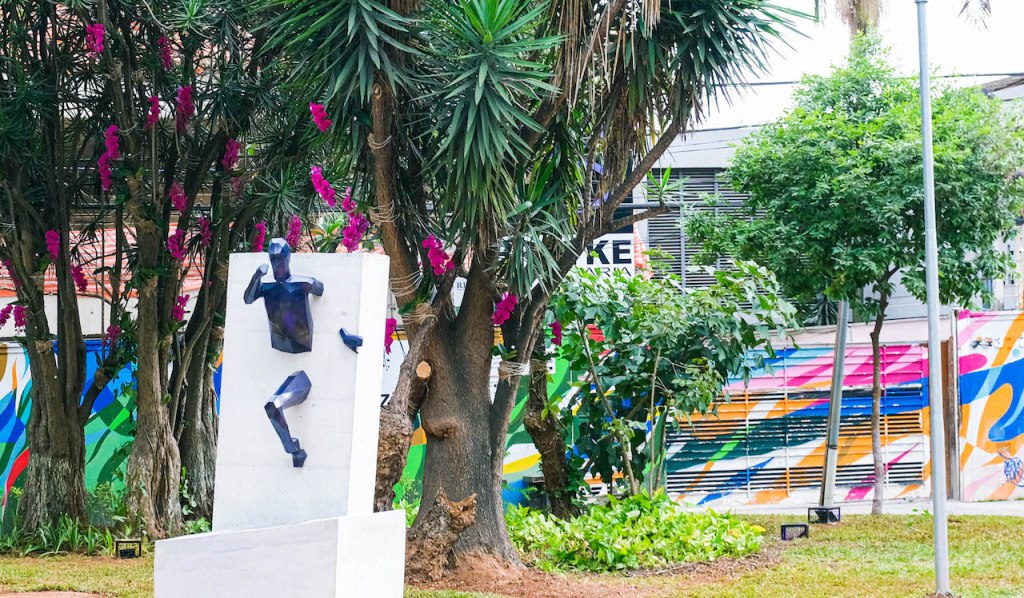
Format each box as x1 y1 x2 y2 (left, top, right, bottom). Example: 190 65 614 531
17 340 88 531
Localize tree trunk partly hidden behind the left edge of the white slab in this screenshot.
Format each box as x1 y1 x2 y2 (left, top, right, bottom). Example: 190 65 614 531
178 327 224 521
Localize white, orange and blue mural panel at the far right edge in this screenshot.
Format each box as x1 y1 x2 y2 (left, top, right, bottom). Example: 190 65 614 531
956 311 1024 501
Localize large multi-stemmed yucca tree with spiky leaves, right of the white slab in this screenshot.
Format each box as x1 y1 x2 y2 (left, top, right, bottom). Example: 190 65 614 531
266 0 788 561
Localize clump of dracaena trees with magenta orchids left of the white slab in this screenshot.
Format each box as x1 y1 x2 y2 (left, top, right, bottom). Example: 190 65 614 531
0 0 317 538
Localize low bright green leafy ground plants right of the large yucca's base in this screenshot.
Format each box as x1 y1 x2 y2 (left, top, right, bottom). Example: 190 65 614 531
505 493 764 571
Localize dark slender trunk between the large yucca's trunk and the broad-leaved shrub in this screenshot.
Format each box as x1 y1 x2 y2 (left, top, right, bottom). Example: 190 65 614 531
523 362 580 519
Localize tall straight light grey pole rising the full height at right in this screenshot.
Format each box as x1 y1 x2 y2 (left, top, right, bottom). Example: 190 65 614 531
914 0 949 596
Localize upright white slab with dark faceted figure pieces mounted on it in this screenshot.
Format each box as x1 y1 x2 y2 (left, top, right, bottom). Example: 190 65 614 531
213 253 388 531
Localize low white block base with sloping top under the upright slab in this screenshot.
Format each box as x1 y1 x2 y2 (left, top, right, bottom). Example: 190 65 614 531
155 511 406 598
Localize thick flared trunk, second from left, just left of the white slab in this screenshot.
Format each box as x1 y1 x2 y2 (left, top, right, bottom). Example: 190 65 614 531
126 237 181 540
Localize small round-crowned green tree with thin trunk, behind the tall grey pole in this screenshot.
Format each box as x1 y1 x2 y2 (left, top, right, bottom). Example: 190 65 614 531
687 37 1024 512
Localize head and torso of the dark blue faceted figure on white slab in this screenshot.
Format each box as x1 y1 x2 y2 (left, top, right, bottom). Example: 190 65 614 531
244 239 324 353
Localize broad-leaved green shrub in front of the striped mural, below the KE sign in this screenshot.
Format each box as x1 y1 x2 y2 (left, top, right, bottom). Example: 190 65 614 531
546 262 795 488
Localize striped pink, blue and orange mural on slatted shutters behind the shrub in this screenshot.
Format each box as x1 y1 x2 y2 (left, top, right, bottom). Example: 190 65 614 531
668 345 928 505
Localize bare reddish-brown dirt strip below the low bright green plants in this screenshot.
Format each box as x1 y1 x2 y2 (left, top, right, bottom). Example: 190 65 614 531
417 546 781 598
